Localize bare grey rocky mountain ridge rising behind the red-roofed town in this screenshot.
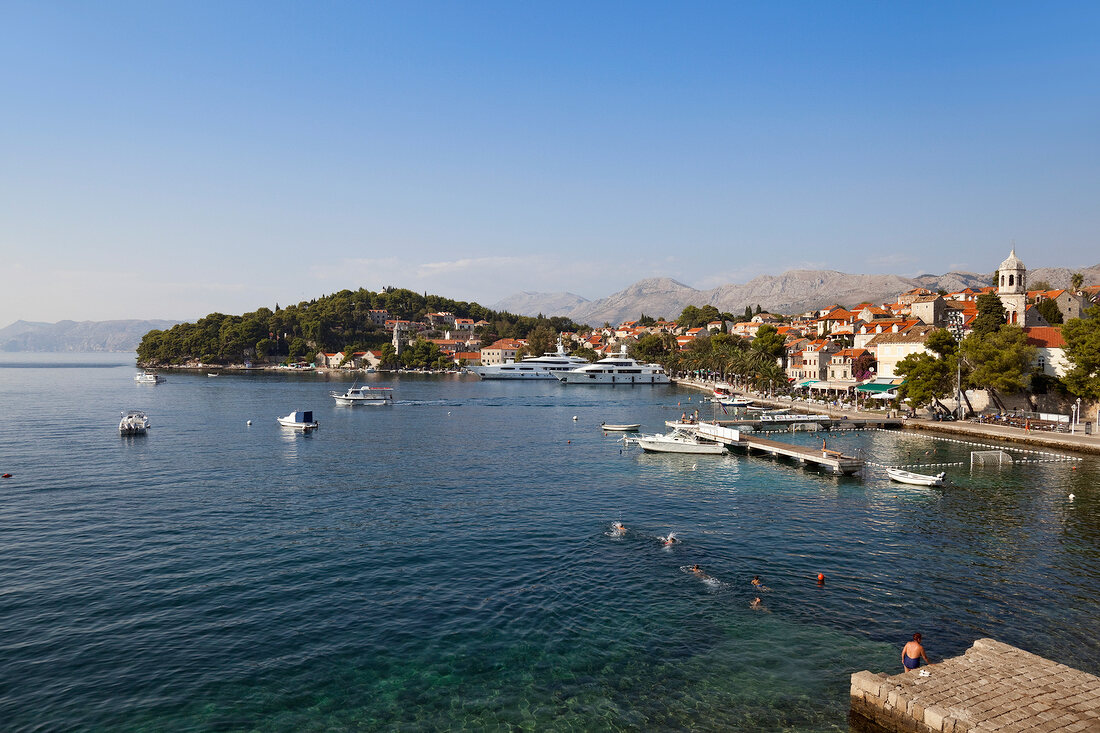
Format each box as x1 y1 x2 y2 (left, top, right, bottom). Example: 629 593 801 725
491 259 1100 326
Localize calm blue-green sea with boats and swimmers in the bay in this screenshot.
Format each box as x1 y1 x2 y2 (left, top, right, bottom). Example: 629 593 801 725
0 354 1100 731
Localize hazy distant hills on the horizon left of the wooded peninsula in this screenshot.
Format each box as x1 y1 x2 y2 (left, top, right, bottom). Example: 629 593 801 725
0 320 179 351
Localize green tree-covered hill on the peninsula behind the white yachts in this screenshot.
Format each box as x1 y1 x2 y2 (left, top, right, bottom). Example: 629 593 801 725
138 288 578 367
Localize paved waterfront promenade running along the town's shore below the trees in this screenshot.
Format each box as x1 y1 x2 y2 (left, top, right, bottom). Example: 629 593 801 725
675 379 1100 455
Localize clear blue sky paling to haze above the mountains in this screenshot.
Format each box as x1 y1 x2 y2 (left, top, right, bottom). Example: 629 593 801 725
0 0 1100 326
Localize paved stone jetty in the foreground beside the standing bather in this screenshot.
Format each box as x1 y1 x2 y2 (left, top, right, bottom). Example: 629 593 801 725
850 638 1100 733
